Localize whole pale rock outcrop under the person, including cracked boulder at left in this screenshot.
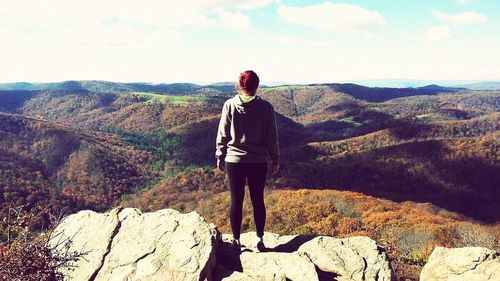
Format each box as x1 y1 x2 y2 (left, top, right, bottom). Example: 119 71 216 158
49 208 392 281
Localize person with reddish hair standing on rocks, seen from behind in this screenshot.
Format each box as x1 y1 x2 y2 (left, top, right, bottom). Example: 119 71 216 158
215 70 280 251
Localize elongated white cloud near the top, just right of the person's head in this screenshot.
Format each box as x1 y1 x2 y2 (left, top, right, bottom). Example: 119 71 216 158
278 2 386 31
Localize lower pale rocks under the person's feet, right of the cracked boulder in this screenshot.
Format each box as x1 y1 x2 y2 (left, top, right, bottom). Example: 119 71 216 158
216 232 392 281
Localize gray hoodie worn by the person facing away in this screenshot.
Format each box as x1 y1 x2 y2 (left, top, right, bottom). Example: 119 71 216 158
215 95 280 164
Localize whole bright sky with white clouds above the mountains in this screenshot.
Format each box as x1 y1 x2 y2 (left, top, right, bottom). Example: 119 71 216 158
0 0 500 84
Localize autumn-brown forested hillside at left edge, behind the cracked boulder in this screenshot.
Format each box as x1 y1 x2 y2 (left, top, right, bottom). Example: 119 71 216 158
0 113 151 216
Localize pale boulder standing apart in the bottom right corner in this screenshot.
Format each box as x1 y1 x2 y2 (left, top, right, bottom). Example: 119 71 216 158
420 247 500 281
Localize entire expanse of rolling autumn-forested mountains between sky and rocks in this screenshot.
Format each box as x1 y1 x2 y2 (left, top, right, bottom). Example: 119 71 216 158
0 81 500 280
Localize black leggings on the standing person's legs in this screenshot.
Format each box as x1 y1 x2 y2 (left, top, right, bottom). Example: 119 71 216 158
226 163 267 239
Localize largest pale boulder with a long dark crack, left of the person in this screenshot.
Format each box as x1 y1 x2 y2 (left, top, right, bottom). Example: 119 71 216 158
49 208 216 281
